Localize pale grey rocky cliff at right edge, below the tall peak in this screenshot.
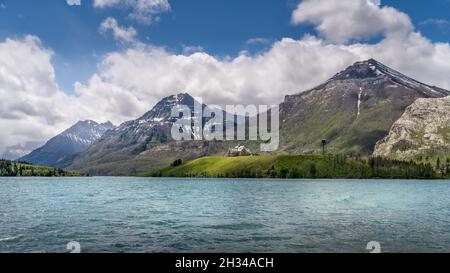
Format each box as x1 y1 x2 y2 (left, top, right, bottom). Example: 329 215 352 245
374 97 450 159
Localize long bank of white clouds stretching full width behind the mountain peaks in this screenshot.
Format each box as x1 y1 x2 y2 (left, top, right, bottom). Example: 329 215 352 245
0 0 450 152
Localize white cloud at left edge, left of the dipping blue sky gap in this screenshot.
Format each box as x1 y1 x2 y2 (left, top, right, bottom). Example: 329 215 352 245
0 36 77 152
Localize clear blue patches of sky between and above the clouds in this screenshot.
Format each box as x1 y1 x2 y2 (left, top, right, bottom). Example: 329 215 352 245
0 0 450 92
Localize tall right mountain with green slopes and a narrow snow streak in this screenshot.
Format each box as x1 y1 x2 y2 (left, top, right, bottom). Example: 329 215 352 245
280 59 450 155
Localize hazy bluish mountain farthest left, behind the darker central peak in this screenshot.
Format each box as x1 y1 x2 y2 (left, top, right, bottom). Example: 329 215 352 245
19 120 114 168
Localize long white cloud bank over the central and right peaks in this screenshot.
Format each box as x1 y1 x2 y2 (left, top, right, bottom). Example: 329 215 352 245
70 33 450 111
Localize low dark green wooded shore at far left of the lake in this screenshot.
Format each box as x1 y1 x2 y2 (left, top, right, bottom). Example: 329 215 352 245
0 160 81 177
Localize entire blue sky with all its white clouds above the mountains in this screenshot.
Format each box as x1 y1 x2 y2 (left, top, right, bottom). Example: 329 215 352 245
0 0 450 155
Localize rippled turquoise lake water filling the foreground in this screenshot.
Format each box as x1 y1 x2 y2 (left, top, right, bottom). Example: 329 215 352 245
0 177 450 253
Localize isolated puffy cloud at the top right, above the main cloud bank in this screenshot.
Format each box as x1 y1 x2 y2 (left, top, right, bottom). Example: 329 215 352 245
292 0 413 43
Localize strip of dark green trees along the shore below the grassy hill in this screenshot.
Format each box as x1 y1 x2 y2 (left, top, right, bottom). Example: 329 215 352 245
152 154 440 179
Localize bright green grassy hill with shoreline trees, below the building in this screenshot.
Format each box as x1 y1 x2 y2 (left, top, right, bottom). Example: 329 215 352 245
143 155 437 179
